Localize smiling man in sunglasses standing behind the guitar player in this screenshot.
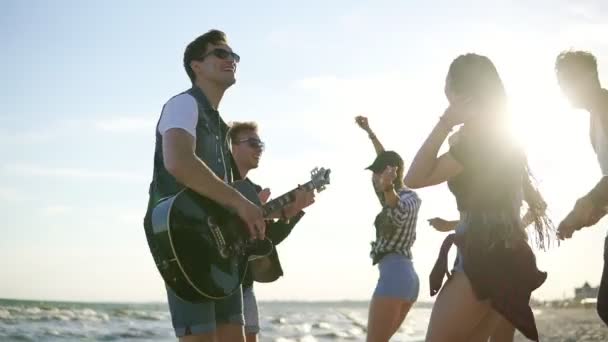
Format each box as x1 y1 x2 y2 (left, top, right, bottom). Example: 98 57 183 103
228 122 314 342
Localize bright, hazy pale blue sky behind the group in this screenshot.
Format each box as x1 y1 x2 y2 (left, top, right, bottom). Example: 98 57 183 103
0 0 608 302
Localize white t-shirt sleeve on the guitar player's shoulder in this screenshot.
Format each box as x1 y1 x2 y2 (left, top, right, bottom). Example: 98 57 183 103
158 93 198 139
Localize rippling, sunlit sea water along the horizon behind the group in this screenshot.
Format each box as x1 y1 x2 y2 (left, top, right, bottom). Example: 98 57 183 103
0 300 431 342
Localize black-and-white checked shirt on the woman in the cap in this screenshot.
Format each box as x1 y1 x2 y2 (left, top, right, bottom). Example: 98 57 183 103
370 188 421 264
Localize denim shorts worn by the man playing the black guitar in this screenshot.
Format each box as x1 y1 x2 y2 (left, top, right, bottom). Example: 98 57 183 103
167 288 245 337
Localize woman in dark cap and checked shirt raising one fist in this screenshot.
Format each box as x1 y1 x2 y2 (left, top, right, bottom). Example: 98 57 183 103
356 116 420 341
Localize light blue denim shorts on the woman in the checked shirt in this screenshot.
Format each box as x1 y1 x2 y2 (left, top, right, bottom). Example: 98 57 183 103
374 253 420 303
